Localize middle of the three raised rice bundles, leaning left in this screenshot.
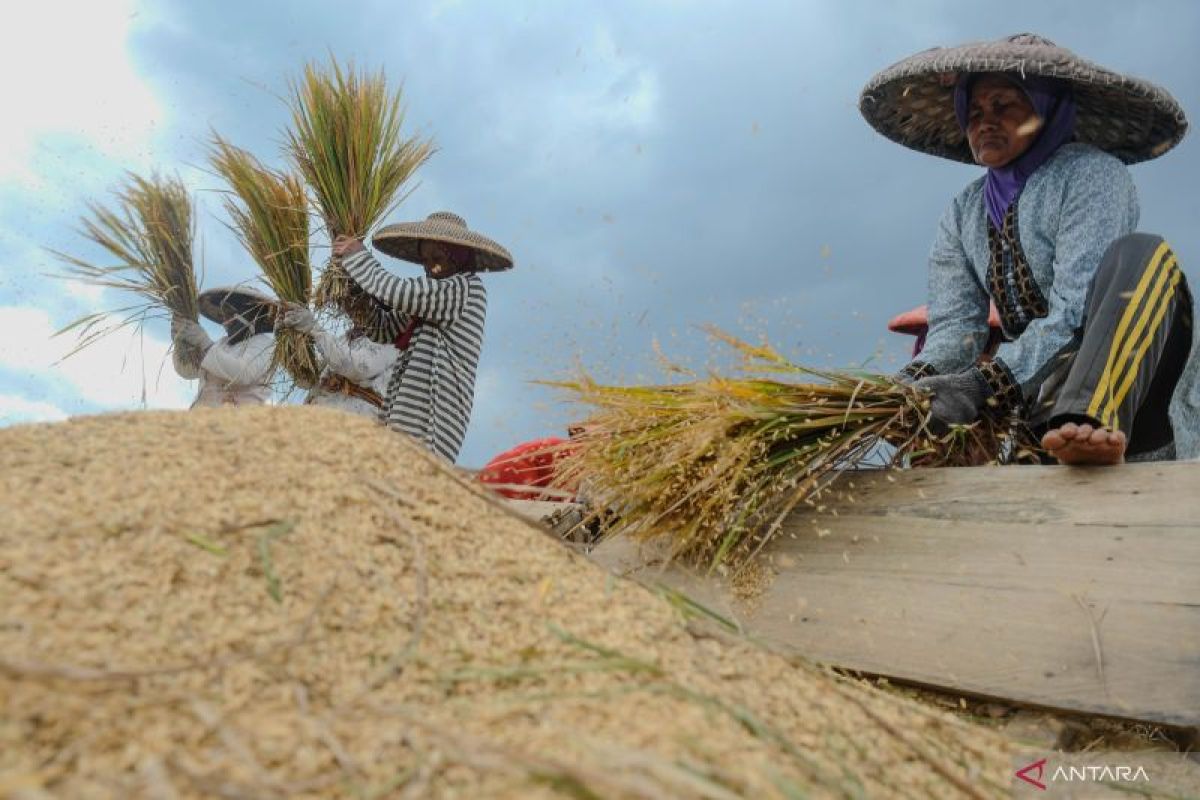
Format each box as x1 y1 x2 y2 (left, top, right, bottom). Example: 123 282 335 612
210 134 320 386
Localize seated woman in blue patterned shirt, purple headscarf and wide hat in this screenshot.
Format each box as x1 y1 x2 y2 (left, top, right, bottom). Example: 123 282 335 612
859 34 1200 464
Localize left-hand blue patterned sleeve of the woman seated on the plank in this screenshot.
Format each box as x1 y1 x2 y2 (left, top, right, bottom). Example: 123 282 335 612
920 199 990 377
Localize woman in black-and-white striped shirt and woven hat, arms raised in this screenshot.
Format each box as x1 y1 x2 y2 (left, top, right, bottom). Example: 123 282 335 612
334 211 512 462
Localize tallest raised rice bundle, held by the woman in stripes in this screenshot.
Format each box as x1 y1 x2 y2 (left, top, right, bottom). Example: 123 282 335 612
288 60 434 324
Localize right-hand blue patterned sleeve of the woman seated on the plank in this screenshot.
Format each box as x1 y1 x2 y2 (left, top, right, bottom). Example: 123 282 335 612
996 154 1138 395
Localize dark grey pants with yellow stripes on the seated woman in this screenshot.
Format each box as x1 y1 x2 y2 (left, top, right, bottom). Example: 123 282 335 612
1030 234 1192 461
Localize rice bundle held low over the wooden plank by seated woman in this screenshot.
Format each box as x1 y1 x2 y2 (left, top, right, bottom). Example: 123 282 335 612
550 330 1026 569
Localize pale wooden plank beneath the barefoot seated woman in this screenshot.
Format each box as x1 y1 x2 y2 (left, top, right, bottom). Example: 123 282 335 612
593 463 1200 726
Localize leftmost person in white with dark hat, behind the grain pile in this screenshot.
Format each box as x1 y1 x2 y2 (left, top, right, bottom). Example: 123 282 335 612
170 287 276 408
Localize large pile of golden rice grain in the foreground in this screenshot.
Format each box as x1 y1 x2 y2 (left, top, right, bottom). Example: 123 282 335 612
0 407 1013 798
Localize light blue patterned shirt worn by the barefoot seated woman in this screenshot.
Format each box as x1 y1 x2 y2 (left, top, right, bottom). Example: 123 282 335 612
919 143 1200 458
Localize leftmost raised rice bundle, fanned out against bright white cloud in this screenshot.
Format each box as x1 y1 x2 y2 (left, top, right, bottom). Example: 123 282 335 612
50 173 199 355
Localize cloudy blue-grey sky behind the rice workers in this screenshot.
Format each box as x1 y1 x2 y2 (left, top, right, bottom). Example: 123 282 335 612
0 0 1200 465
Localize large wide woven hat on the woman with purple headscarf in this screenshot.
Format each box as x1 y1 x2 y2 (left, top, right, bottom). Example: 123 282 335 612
858 34 1188 164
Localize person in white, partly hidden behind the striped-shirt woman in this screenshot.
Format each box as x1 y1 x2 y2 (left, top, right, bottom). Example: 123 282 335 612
277 302 400 419
